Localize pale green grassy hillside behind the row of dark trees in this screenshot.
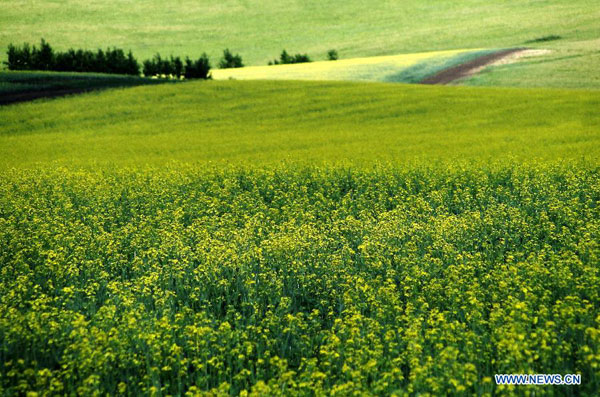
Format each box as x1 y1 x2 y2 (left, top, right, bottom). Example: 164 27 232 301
0 0 600 65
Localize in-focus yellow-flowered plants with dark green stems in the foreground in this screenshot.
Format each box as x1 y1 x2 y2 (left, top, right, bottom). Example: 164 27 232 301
0 165 600 396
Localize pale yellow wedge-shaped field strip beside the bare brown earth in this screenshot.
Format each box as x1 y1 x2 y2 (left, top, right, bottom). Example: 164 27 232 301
212 50 482 83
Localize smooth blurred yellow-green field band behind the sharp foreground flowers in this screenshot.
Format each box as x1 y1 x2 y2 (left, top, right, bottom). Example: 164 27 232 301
0 81 600 167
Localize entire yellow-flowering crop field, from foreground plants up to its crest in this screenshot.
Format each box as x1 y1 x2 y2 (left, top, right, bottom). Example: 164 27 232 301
0 81 600 396
